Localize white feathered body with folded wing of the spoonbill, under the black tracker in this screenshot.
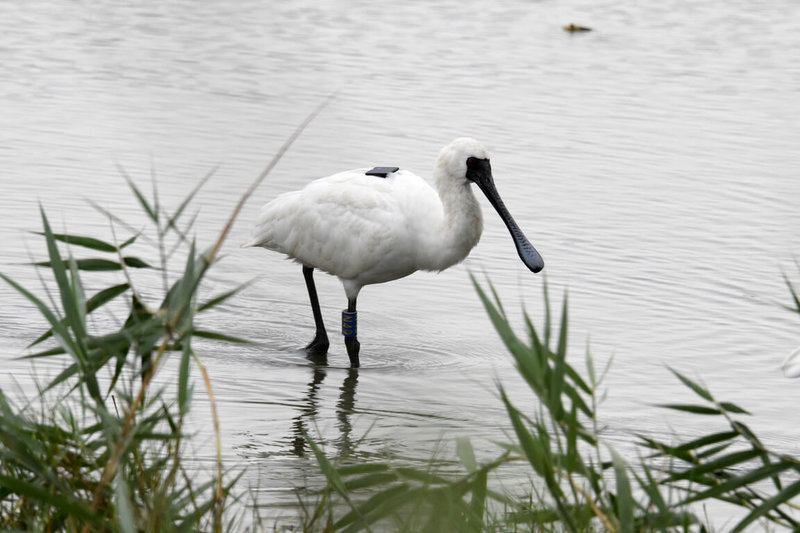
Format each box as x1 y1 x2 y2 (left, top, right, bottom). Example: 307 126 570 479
251 170 441 282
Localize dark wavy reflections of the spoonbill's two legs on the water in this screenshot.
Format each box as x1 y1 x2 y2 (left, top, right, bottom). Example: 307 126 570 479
292 360 358 457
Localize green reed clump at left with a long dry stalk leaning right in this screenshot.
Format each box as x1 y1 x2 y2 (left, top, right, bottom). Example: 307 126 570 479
0 101 327 532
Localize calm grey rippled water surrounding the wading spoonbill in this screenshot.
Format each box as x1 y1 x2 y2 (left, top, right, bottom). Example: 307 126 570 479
0 0 800 516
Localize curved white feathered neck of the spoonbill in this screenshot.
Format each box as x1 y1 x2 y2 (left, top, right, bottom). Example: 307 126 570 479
418 168 483 270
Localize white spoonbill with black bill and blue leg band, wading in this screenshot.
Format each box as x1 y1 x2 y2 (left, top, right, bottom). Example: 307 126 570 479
244 138 544 367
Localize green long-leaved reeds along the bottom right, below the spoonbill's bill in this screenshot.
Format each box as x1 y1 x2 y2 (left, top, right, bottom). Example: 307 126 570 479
305 278 800 532
